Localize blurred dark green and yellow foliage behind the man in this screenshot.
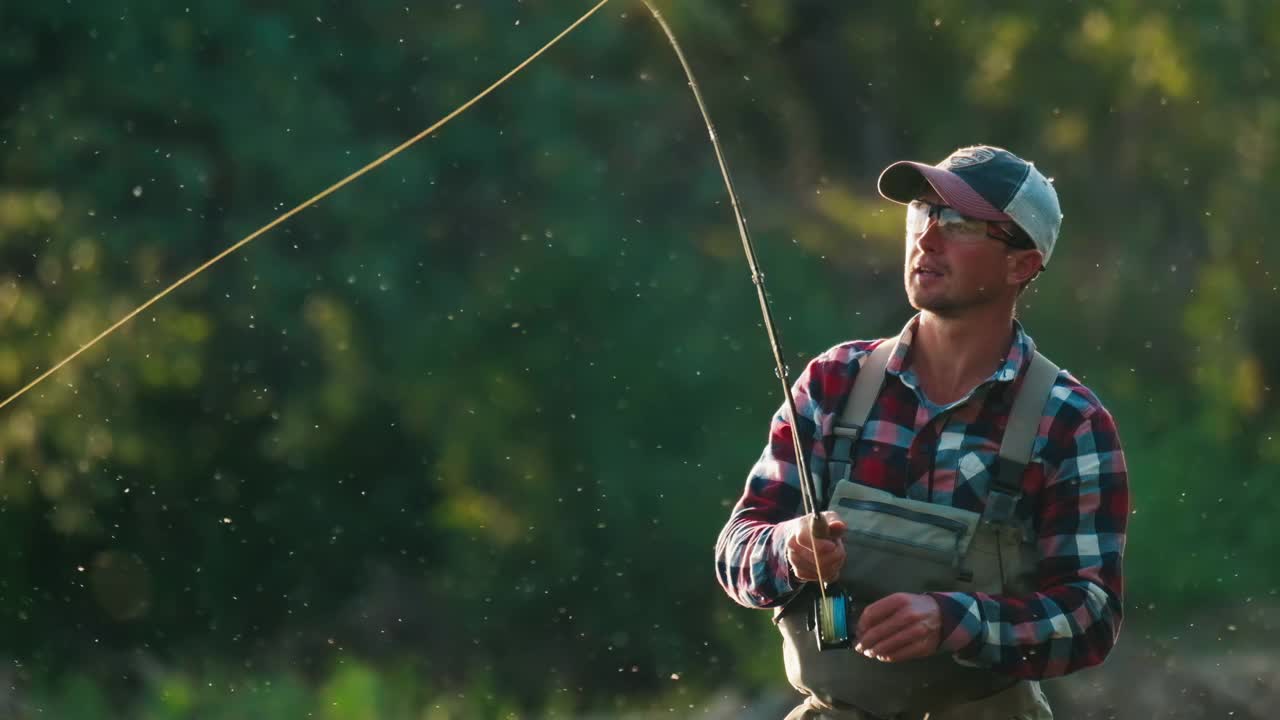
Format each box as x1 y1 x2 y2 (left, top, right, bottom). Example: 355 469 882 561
0 0 1280 719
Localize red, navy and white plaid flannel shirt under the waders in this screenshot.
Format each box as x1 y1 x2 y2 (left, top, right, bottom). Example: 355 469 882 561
716 316 1129 679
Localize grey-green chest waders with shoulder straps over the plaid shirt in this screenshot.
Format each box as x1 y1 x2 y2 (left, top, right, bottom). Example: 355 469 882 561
774 342 1059 720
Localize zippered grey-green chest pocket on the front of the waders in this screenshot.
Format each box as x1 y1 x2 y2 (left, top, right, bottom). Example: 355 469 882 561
831 483 979 601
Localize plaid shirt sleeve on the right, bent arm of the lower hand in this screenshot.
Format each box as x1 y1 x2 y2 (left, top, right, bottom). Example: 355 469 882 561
929 405 1129 679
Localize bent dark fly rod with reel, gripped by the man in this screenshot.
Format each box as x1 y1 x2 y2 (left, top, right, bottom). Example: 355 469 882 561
641 0 850 650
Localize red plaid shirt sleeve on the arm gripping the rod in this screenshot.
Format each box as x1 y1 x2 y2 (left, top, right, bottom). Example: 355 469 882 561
716 348 849 607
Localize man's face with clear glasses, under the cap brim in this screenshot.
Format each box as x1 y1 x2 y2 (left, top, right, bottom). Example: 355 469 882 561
904 191 1016 316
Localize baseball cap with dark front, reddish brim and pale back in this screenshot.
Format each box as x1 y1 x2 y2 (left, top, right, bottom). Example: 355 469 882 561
878 145 1062 265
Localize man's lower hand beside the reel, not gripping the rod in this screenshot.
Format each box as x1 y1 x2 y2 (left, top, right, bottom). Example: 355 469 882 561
854 592 942 662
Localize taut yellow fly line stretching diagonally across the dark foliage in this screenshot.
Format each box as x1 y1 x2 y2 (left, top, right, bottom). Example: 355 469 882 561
0 0 609 407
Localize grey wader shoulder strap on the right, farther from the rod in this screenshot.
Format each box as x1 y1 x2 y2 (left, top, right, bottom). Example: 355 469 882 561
982 352 1059 525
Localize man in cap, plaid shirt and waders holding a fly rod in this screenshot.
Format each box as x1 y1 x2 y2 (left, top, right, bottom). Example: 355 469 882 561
716 146 1129 720
